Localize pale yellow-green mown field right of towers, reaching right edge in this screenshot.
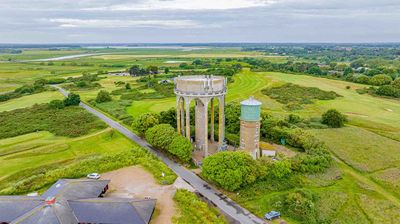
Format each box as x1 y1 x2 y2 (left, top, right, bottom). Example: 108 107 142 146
265 72 400 128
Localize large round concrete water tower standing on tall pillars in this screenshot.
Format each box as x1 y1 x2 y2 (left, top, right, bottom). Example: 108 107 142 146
174 75 227 157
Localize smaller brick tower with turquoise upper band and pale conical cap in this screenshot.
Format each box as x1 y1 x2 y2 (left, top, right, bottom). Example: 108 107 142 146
240 97 261 159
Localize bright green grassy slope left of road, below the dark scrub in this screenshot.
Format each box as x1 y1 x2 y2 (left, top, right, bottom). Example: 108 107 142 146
0 129 123 180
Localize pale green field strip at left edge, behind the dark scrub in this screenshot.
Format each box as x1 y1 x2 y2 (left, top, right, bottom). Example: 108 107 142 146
0 91 64 112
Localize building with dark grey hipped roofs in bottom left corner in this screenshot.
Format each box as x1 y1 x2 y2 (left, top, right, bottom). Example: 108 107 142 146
0 179 156 224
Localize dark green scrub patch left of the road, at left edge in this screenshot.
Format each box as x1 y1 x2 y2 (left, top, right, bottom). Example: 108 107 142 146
0 104 106 139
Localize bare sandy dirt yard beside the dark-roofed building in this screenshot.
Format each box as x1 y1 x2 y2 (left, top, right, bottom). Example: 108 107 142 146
102 166 176 224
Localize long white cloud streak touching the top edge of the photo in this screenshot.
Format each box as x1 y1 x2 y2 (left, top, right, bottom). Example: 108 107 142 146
85 0 277 11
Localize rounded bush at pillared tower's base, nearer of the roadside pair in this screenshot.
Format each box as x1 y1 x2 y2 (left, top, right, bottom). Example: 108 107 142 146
167 135 193 162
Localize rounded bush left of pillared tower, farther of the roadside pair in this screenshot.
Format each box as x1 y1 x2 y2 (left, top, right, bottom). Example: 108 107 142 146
145 124 177 149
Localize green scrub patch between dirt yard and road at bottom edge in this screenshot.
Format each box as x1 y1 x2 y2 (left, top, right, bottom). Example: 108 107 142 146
172 189 228 224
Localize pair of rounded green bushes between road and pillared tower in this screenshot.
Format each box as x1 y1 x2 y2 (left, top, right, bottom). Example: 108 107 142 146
145 124 193 163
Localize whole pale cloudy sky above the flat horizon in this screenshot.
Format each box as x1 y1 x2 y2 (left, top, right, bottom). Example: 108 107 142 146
0 0 400 44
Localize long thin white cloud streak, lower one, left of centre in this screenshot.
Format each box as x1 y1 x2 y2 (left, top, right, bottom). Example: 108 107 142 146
48 18 200 28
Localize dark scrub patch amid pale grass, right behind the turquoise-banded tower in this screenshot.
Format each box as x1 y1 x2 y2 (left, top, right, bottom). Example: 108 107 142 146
261 83 340 107
